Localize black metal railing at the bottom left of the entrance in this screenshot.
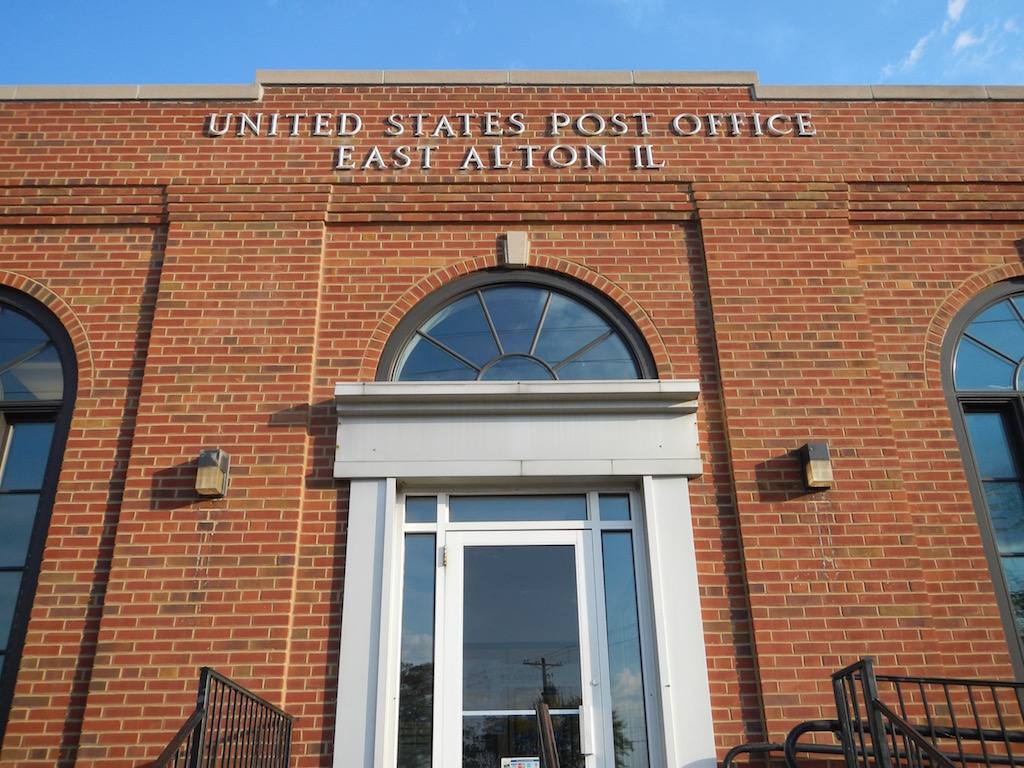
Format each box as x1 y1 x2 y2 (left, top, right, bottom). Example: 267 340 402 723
142 667 292 768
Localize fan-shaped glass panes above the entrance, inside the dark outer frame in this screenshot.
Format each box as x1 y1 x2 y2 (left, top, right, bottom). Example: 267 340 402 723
391 283 647 381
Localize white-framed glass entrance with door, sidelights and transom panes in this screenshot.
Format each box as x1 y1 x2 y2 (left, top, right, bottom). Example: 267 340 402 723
396 493 650 768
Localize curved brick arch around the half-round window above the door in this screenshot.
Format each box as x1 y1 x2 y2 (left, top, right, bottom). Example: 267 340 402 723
359 254 672 381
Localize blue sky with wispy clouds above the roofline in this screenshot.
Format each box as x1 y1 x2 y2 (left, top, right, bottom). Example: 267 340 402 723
0 0 1024 85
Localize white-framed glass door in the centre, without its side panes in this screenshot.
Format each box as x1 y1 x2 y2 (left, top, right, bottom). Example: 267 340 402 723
435 530 604 768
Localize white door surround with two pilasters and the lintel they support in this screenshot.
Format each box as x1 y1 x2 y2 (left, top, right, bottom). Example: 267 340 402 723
334 379 717 768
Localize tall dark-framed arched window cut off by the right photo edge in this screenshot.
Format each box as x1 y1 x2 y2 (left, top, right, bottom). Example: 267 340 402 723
943 281 1024 671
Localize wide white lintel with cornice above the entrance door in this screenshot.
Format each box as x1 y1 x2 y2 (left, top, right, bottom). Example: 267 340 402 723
335 380 701 479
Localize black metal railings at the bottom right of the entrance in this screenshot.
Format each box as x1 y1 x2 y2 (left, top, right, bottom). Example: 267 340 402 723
723 658 1024 768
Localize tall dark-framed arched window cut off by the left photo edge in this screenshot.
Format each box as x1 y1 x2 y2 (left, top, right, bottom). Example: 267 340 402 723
0 290 77 738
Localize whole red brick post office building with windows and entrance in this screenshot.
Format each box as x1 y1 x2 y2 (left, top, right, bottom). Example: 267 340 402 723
0 72 1024 768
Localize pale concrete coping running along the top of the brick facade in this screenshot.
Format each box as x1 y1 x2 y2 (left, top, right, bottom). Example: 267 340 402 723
0 70 1024 101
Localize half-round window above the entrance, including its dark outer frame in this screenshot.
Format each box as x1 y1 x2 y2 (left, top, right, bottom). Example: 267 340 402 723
378 271 655 381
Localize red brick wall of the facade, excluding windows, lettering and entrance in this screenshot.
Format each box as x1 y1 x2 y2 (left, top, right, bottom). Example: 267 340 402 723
0 81 1024 766
